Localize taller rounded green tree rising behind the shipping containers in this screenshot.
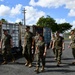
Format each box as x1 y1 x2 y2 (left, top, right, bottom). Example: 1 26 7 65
36 15 58 32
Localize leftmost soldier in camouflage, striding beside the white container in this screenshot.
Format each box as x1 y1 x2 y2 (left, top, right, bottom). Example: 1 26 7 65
2 30 15 64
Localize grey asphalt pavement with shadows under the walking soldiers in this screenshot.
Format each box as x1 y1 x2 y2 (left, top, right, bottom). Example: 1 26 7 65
0 43 75 75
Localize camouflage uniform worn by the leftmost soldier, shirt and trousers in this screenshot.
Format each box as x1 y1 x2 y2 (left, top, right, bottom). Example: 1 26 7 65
3 34 15 61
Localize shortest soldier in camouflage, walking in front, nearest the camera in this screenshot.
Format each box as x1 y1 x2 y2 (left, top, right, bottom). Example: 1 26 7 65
35 35 47 73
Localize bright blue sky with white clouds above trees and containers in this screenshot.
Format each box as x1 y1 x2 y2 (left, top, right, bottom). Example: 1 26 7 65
0 0 75 28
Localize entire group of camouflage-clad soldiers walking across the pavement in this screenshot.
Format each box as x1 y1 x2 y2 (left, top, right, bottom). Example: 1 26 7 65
2 26 75 73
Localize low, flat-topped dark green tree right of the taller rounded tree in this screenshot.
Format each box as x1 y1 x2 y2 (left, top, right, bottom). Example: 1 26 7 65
58 23 72 33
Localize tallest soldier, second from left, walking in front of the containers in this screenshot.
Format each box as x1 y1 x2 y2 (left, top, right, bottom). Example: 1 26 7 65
23 26 34 67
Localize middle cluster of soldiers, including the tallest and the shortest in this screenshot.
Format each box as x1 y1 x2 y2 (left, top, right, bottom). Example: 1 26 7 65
23 26 47 73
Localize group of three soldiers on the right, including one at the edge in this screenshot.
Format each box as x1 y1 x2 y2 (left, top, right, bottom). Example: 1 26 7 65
50 30 75 66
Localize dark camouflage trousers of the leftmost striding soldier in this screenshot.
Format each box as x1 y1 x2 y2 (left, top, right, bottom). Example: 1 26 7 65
3 47 15 61
